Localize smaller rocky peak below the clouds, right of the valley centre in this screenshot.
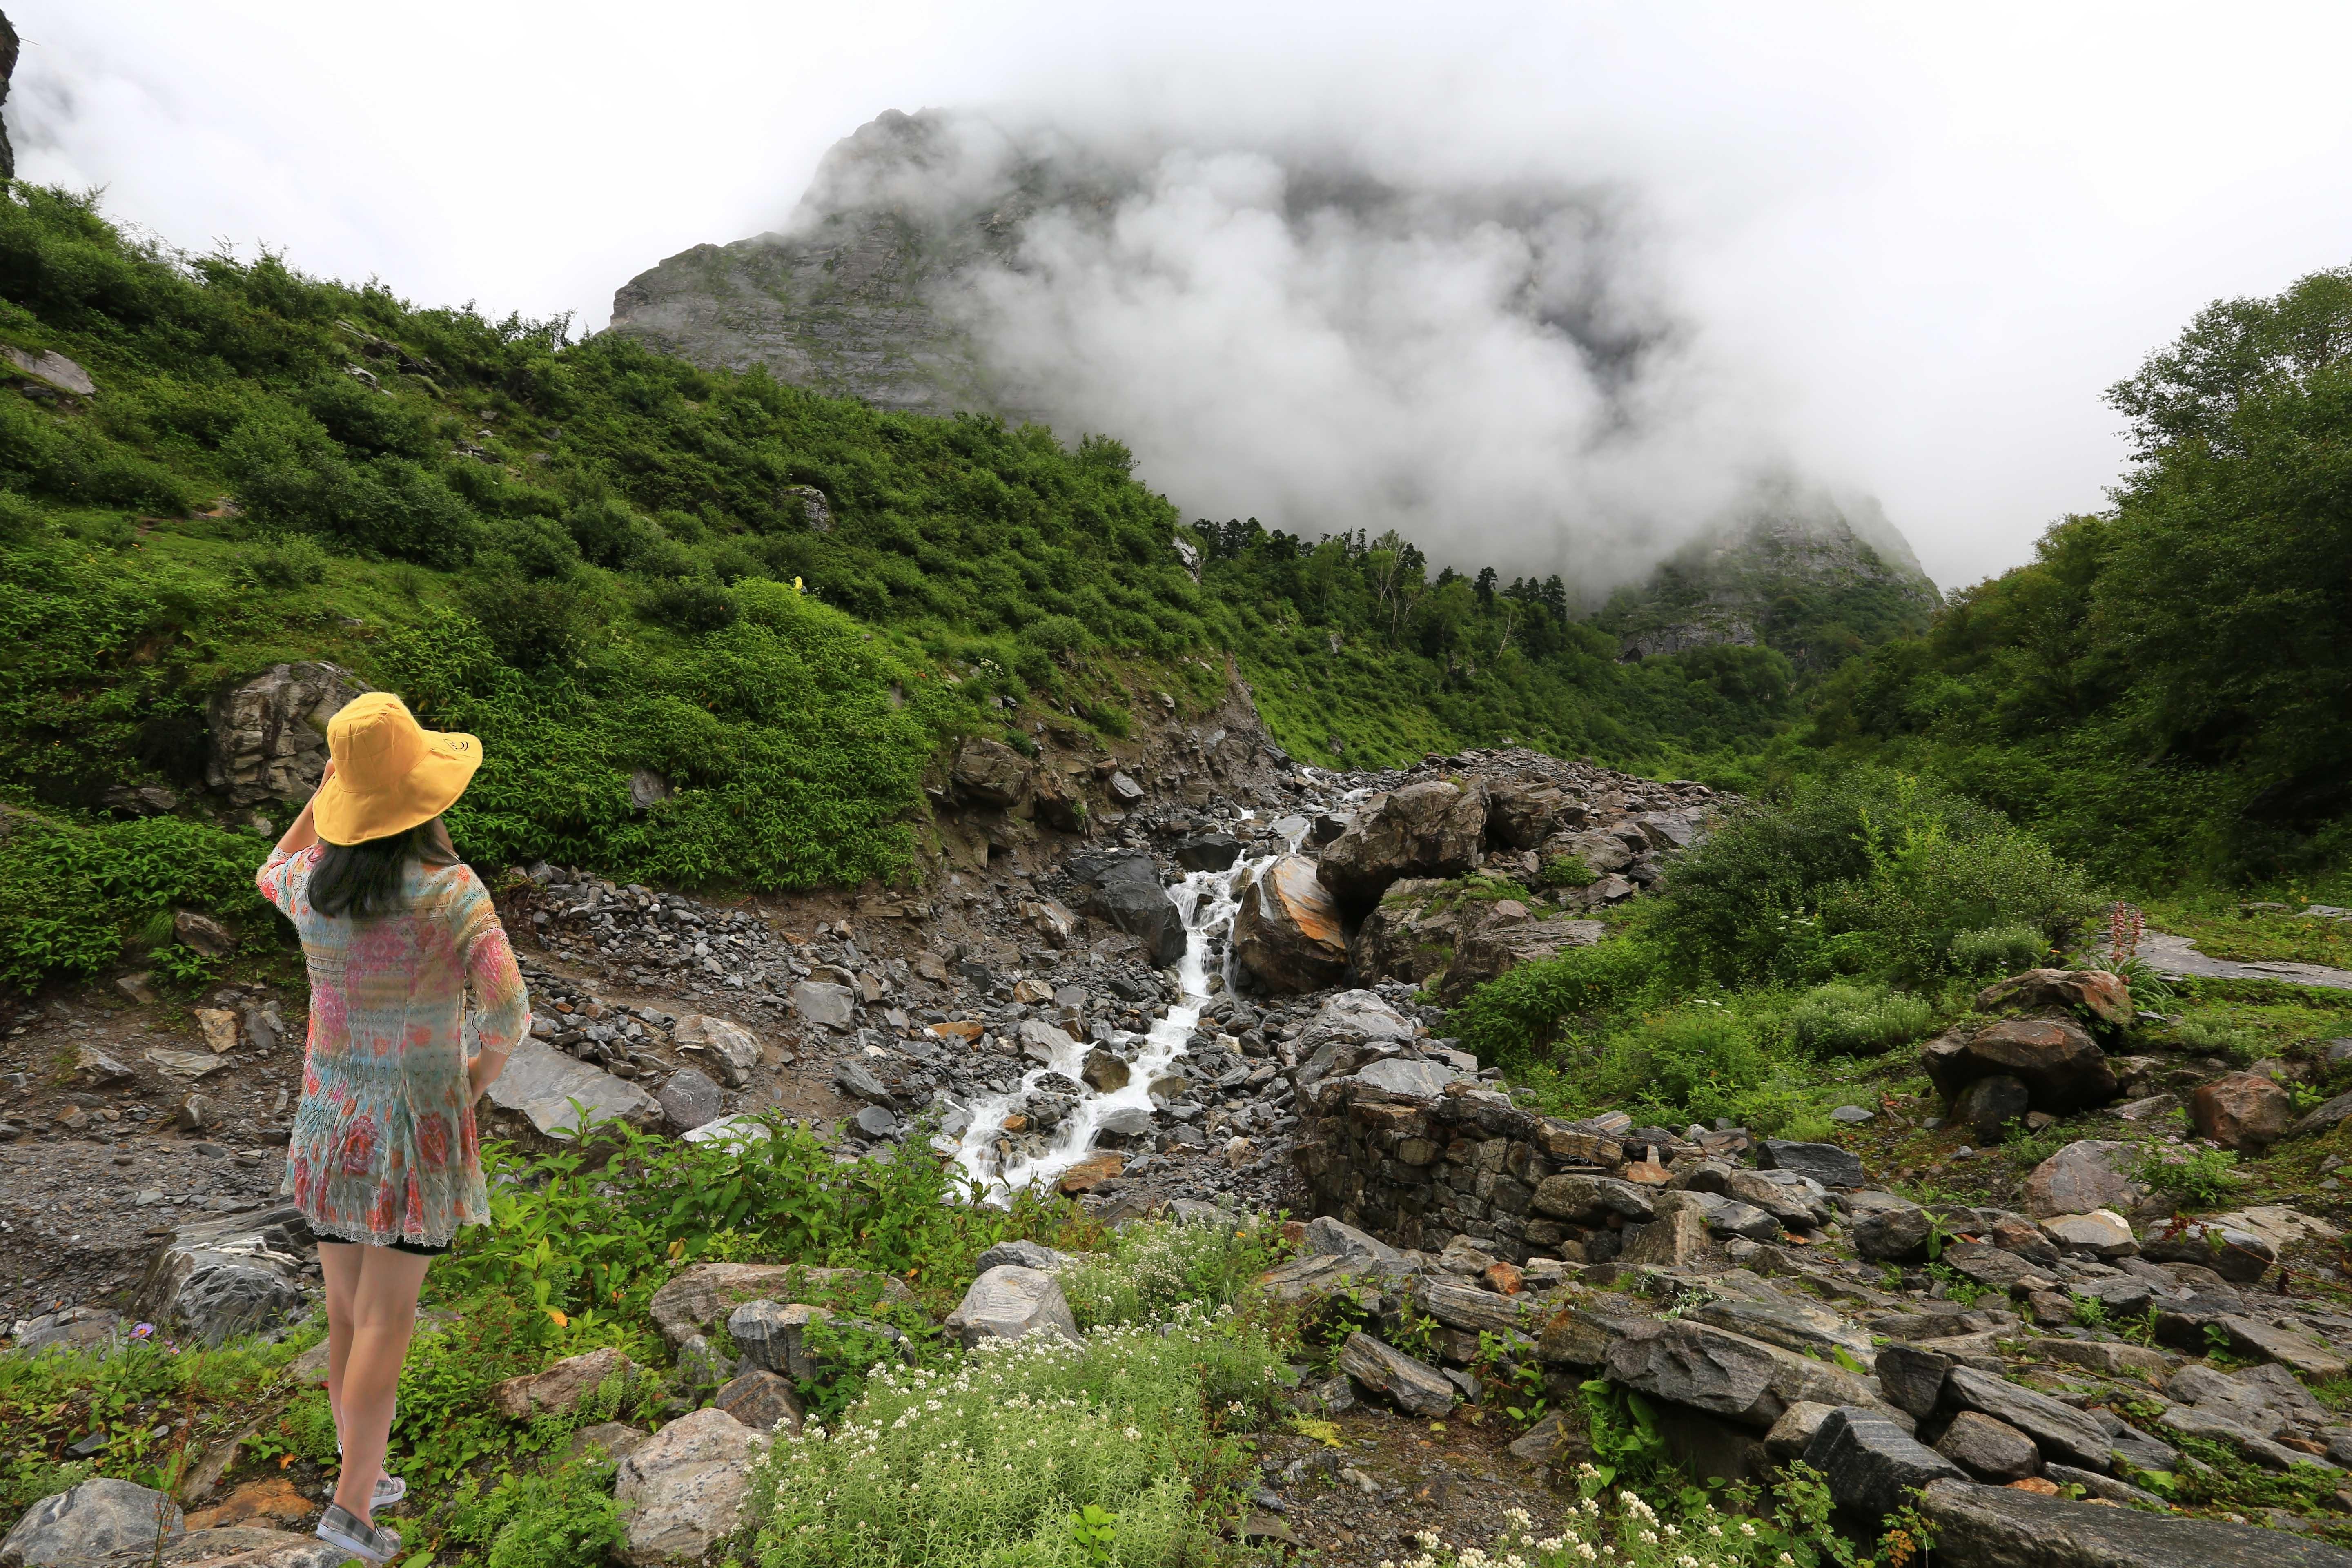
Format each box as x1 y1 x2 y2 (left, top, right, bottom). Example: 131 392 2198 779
1597 477 1943 670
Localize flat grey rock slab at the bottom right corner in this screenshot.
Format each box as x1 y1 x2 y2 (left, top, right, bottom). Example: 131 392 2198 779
1919 1476 2352 1568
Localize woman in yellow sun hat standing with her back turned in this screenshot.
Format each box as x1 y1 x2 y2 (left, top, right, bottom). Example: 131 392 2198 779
256 691 532 1563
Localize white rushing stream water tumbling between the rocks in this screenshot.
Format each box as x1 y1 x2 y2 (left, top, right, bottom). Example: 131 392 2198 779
955 822 1296 1199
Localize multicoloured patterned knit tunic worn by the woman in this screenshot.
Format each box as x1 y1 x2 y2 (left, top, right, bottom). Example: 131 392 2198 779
254 846 532 1246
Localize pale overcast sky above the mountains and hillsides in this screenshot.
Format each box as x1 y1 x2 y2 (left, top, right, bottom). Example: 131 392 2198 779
0 0 2352 588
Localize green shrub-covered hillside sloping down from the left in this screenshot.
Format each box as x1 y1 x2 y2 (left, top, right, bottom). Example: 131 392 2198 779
0 186 1919 980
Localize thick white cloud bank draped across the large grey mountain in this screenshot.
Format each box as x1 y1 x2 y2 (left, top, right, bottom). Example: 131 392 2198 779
793 111 1788 592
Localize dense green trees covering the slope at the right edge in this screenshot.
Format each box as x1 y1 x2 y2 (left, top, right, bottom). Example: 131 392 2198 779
1806 268 2352 882
